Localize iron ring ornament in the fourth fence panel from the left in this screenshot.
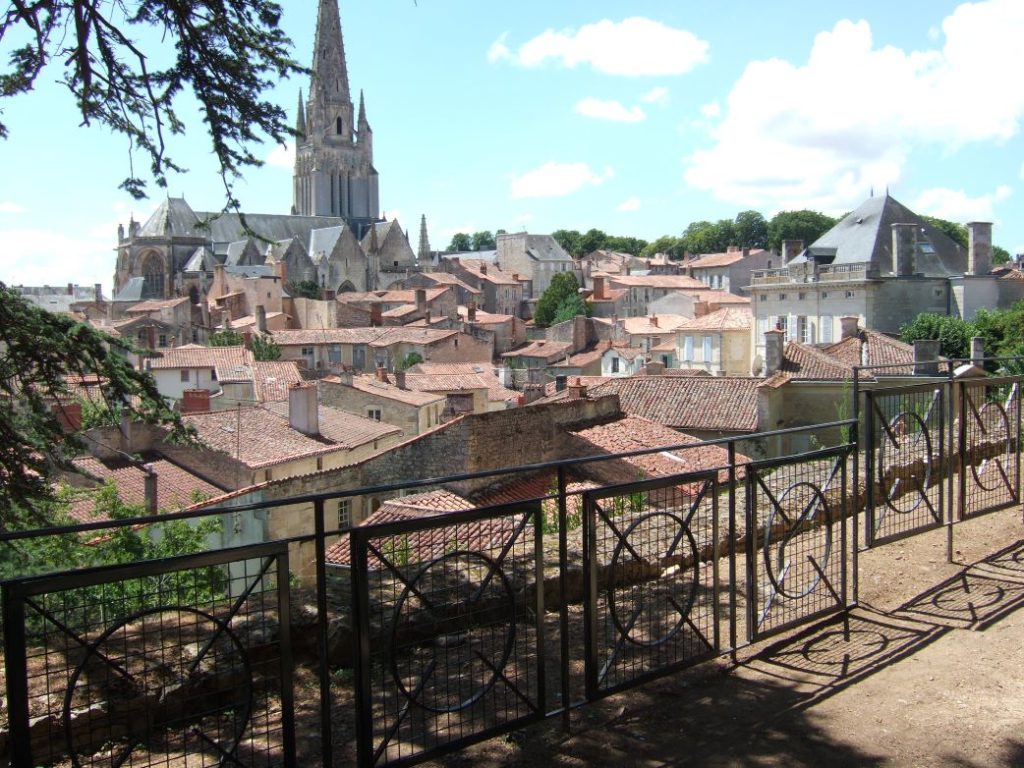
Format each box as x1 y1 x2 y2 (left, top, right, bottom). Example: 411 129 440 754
764 482 831 600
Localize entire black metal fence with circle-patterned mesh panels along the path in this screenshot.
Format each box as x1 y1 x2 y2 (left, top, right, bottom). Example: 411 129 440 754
0 364 1021 766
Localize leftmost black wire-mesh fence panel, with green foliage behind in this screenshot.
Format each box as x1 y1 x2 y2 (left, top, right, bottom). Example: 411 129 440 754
2 543 295 766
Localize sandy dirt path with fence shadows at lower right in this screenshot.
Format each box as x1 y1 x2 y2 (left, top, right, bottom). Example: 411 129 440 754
436 508 1024 768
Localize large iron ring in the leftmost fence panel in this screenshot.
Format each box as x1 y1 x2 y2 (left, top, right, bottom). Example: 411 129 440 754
62 605 253 768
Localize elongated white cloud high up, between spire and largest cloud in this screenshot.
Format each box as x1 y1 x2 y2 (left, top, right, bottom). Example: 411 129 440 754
487 16 710 77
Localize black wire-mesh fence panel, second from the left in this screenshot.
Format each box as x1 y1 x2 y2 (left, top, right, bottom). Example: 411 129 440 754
351 504 545 765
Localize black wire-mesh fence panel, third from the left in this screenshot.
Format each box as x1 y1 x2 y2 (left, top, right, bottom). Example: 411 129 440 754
584 471 721 699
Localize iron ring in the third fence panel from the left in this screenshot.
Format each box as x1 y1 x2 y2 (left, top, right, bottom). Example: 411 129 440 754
607 511 700 648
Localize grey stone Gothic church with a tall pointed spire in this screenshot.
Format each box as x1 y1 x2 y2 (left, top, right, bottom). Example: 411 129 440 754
114 0 419 301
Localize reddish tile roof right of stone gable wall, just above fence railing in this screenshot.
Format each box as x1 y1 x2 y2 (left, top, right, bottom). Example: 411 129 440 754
573 416 749 479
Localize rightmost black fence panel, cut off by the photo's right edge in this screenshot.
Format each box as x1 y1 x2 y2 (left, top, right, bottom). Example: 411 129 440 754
956 377 1021 519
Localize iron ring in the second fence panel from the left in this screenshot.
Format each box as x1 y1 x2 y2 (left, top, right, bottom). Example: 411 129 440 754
390 550 516 715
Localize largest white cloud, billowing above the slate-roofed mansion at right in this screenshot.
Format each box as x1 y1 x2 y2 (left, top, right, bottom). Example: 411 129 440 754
685 0 1024 211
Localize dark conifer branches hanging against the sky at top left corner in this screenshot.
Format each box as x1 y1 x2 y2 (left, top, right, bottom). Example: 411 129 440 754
0 0 305 209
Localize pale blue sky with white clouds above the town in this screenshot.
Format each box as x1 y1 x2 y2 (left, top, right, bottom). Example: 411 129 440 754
0 0 1024 290
